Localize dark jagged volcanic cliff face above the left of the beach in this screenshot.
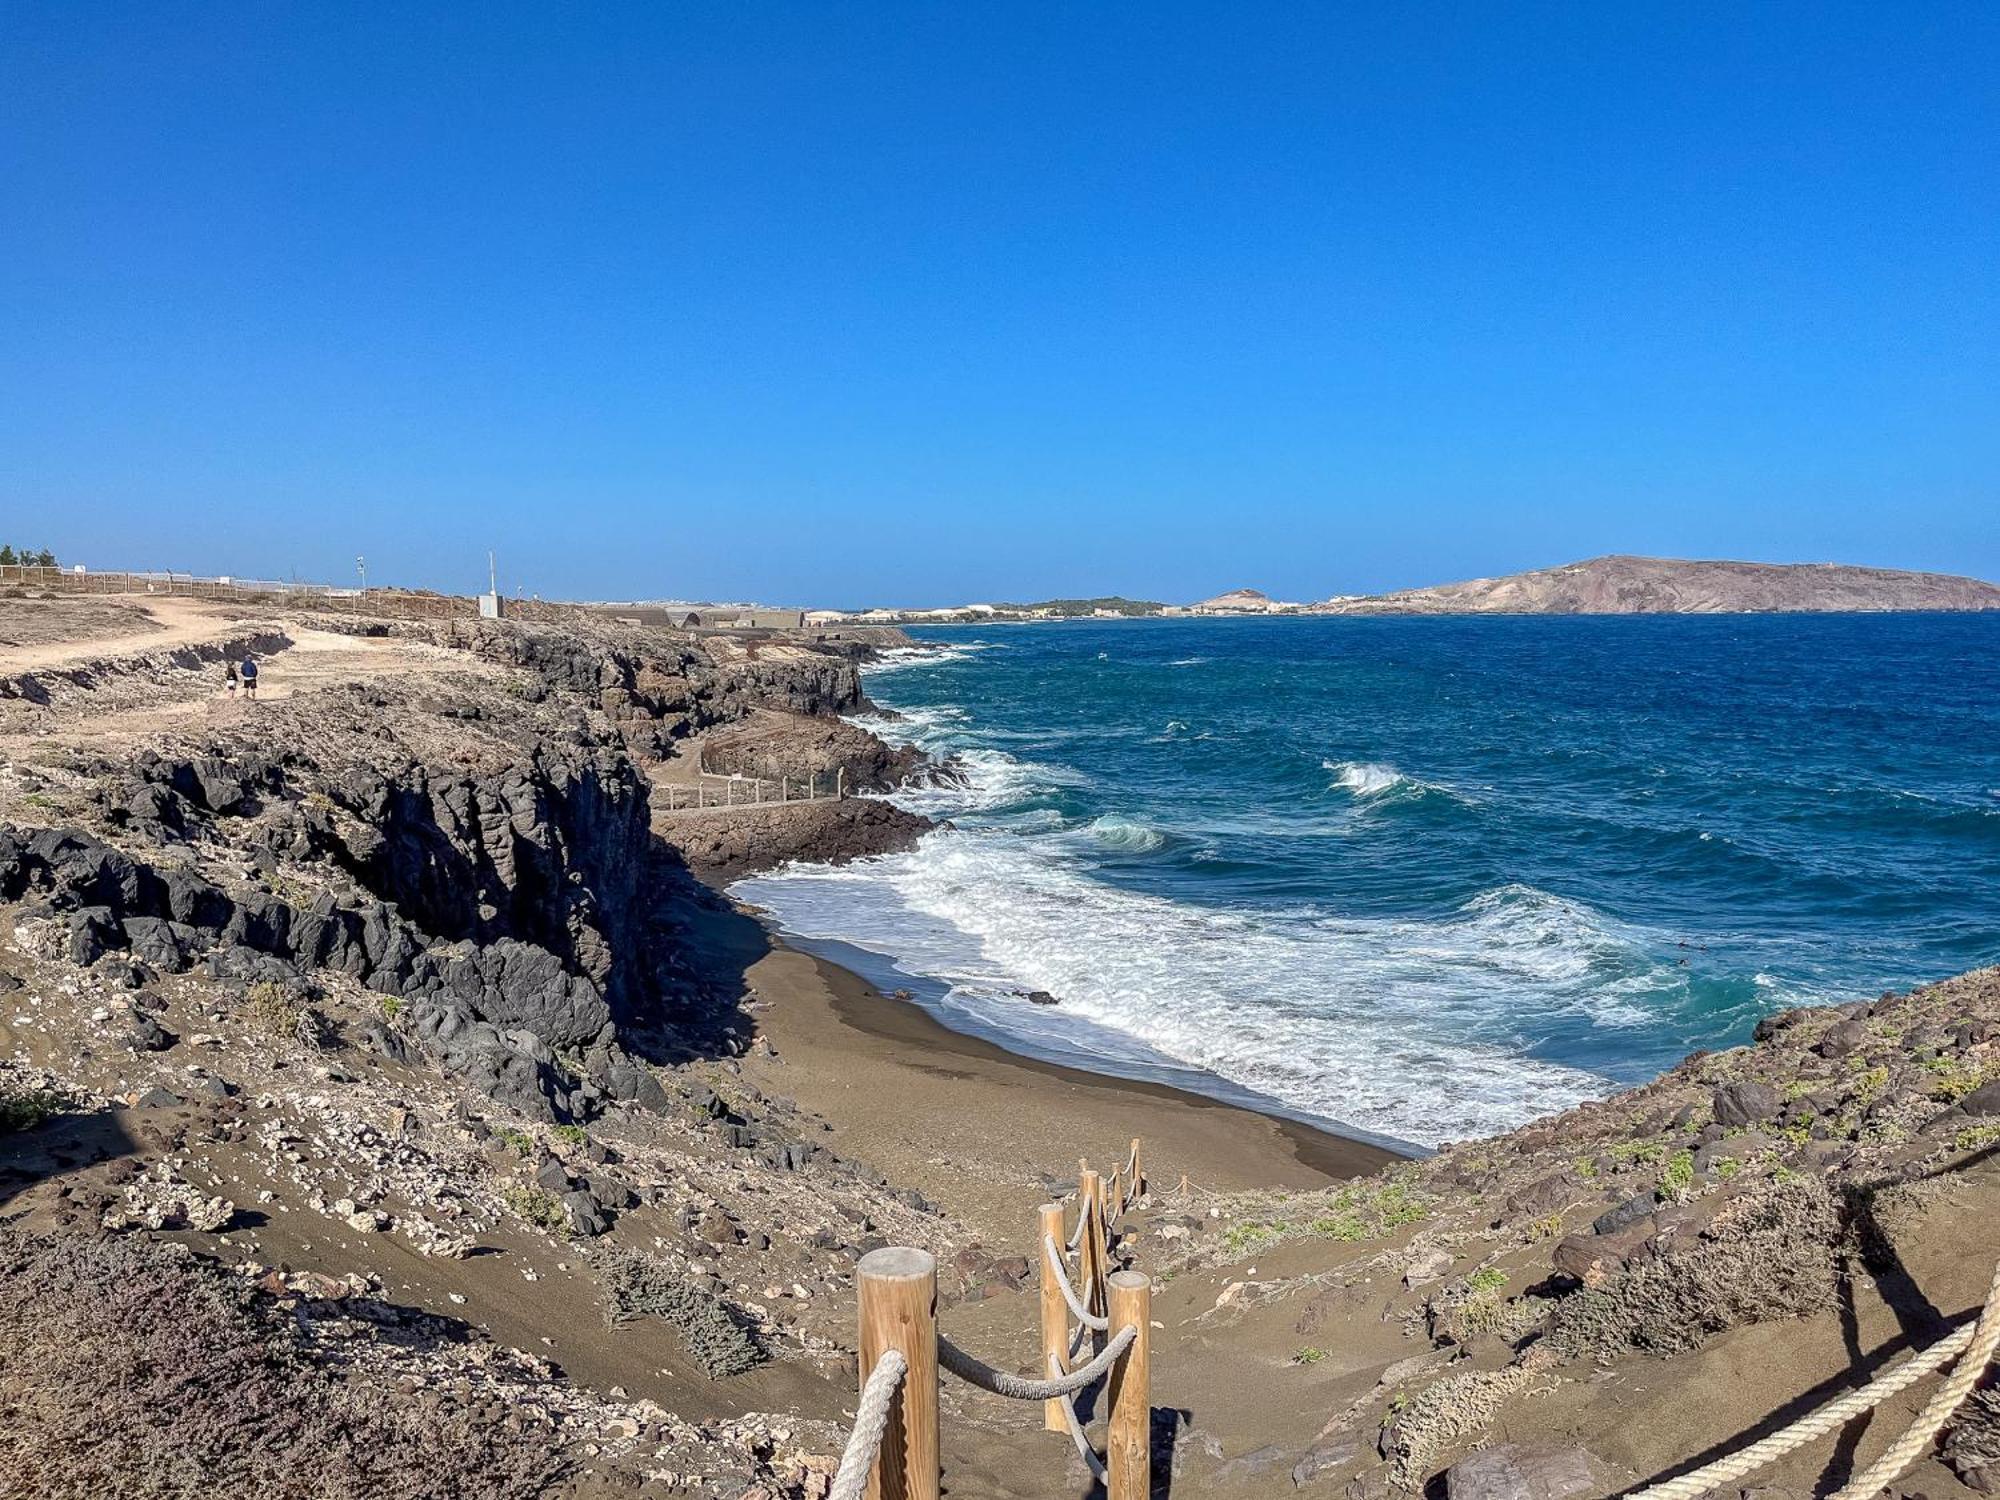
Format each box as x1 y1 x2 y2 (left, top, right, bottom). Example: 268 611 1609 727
0 622 928 1120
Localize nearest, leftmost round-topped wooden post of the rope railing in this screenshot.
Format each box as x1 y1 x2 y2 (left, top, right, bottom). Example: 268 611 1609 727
854 1246 940 1500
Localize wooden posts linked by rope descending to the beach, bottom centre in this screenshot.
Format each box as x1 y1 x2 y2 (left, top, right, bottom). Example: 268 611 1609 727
830 1140 1152 1500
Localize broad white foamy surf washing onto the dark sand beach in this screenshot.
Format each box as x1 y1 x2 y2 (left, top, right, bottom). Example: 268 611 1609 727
736 830 1674 1142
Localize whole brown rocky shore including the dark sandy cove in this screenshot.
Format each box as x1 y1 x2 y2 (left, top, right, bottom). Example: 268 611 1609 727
0 600 2000 1500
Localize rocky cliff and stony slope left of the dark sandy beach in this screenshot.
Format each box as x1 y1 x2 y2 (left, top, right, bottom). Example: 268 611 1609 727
0 602 956 1500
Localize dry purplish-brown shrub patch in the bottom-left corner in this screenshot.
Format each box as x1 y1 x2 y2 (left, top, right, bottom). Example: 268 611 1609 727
0 1230 562 1500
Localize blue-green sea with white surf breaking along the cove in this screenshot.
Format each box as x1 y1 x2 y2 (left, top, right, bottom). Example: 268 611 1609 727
736 614 2000 1146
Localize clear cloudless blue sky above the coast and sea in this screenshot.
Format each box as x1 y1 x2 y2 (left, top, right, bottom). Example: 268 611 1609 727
0 0 2000 604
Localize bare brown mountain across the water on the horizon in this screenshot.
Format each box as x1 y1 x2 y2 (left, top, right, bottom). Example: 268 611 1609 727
1310 556 2000 614
